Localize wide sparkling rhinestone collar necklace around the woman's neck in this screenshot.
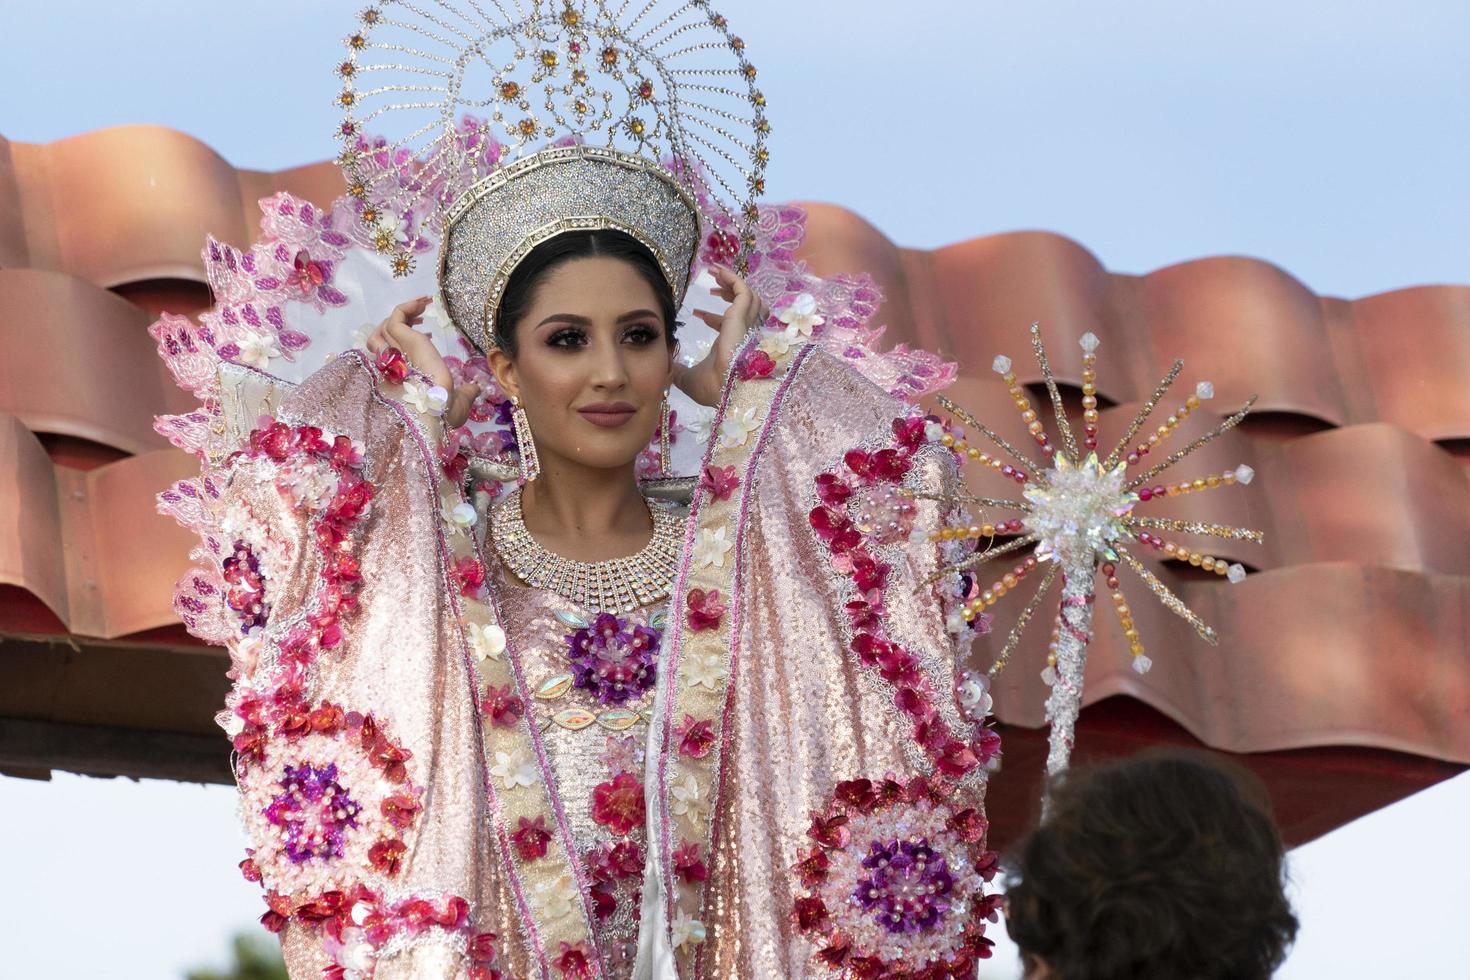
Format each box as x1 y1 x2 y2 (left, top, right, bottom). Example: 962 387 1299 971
490 489 684 613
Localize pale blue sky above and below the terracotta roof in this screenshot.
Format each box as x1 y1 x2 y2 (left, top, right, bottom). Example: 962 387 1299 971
0 0 1470 979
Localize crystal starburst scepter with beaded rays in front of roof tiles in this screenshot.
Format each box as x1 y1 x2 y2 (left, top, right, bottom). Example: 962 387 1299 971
925 323 1261 776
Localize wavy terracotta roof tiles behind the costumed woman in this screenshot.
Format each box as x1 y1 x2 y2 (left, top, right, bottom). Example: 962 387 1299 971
0 126 1470 811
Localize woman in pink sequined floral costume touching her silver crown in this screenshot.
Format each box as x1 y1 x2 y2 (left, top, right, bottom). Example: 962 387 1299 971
154 4 995 977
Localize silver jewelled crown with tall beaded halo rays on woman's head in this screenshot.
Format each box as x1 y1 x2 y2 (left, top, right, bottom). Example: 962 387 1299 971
337 0 770 350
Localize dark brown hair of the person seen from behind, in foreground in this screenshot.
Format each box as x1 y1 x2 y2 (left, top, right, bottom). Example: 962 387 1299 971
1007 749 1297 980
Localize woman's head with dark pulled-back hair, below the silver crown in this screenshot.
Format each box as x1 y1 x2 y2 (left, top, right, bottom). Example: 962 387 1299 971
488 231 676 469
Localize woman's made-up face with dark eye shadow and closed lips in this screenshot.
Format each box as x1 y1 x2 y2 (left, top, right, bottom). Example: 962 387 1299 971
490 256 673 469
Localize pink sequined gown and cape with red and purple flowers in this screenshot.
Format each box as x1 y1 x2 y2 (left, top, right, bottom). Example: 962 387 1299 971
192 345 994 980
